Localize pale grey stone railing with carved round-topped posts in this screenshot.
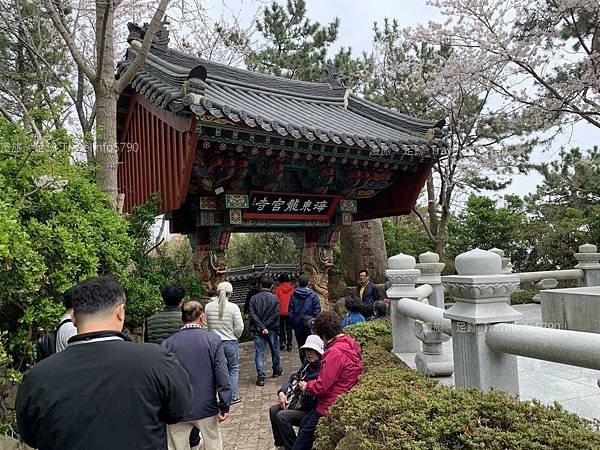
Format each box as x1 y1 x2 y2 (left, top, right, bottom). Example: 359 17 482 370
386 245 600 395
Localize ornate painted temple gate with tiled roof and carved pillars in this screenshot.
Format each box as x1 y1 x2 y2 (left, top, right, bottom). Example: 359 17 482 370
117 24 446 306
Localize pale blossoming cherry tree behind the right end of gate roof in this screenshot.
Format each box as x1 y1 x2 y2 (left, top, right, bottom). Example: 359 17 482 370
365 20 537 256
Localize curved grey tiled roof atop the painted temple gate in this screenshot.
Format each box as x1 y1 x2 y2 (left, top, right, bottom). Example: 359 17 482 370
117 27 446 155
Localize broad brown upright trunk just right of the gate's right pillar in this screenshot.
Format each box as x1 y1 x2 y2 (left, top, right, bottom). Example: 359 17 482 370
340 219 387 286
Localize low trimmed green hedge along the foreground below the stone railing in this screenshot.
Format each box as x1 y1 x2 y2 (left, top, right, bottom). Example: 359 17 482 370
315 321 600 450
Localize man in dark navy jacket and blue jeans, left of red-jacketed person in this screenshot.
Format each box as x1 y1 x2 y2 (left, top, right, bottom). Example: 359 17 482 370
248 276 283 386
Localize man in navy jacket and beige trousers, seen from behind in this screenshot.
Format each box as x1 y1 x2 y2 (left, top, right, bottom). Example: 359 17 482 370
161 300 231 450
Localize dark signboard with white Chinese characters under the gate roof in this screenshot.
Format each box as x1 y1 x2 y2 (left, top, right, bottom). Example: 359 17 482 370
243 191 340 220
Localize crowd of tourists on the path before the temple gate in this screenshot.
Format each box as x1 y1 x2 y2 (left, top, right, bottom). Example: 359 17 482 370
16 271 386 450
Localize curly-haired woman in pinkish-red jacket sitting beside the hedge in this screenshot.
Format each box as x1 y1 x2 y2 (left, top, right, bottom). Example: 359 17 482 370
292 311 362 450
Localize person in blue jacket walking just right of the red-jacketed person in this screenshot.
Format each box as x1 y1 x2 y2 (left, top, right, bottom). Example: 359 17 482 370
288 275 321 364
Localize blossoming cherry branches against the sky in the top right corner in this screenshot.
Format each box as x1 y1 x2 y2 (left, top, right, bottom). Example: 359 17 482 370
416 0 600 129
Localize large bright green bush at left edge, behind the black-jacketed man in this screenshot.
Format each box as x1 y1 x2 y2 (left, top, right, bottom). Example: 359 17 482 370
0 119 132 370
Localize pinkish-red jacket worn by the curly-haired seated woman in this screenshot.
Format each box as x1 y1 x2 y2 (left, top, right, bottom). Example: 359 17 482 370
306 335 362 416
